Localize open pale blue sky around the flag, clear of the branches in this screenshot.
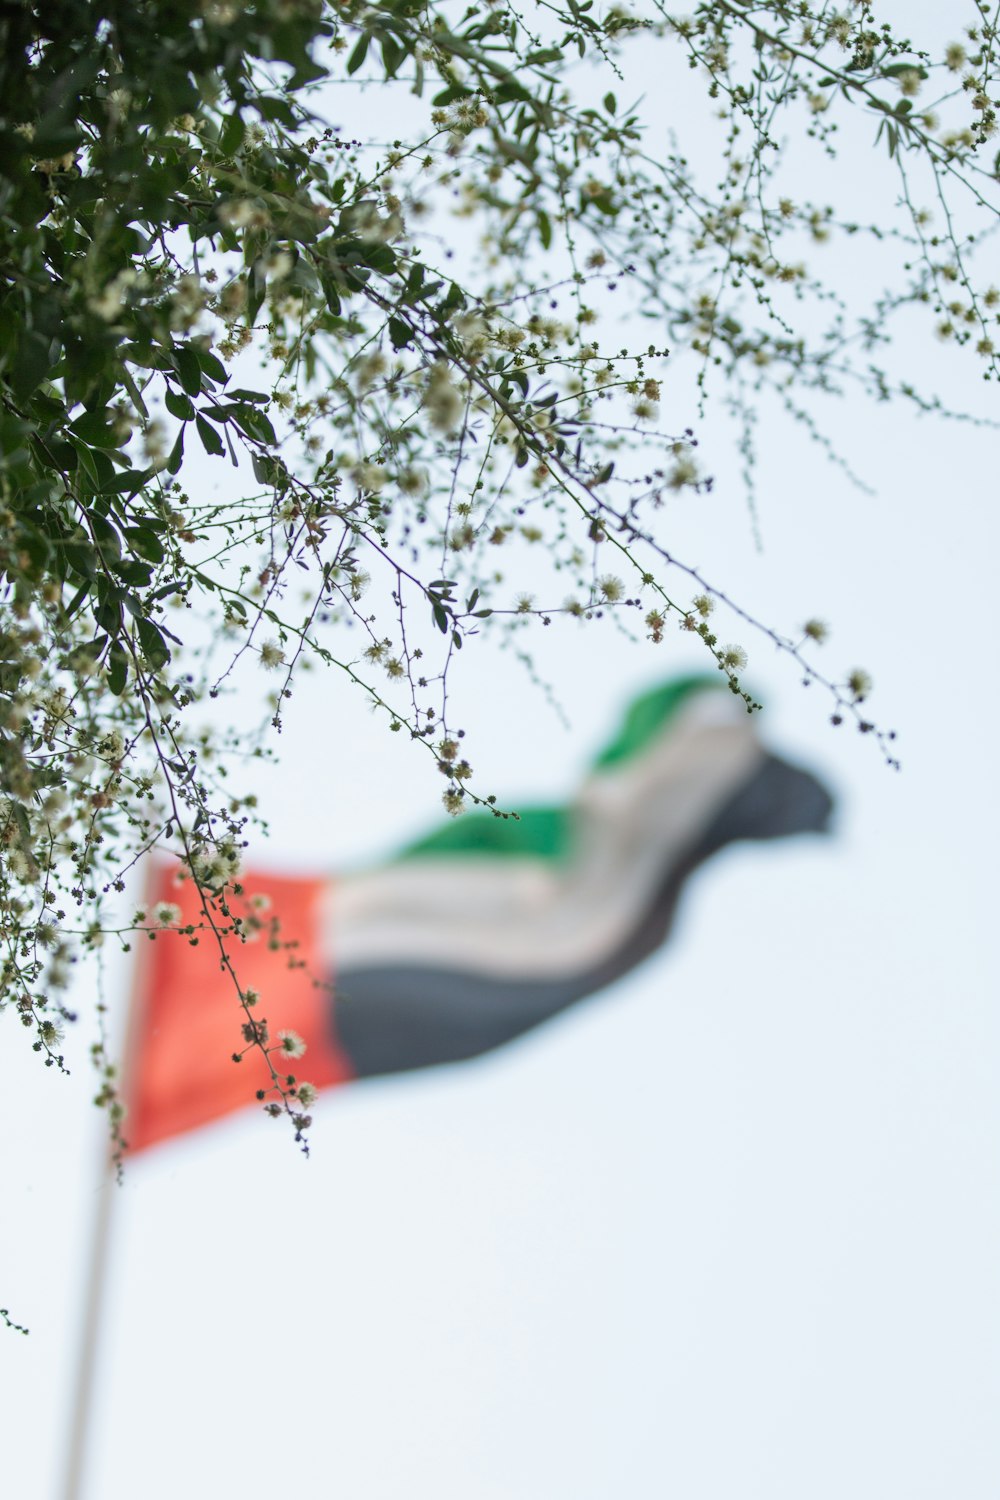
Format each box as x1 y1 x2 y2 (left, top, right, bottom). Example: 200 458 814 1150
0 11 1000 1500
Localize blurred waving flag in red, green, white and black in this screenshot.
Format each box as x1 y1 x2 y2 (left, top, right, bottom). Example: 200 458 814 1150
124 677 832 1152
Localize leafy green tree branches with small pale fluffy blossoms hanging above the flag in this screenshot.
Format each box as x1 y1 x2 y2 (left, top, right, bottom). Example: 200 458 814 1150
0 0 1000 1158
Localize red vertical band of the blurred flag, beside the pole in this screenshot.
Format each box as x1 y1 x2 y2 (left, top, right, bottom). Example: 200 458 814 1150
124 869 352 1152
